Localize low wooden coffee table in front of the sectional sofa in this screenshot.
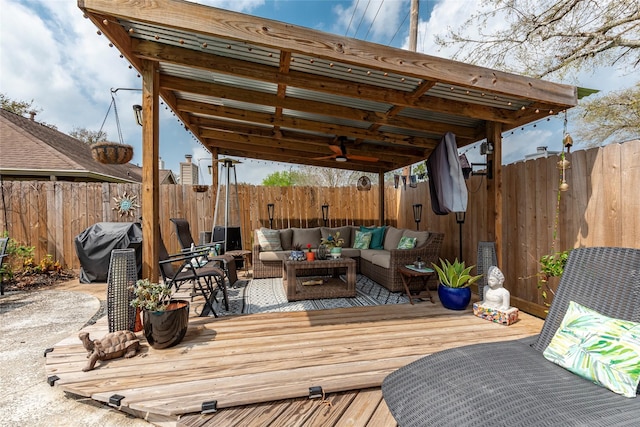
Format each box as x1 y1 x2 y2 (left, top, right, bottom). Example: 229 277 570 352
282 258 356 301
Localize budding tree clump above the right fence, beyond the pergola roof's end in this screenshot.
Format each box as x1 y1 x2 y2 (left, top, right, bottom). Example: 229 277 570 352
571 83 640 147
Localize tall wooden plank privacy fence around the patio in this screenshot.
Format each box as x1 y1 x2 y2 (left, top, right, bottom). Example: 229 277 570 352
0 140 640 312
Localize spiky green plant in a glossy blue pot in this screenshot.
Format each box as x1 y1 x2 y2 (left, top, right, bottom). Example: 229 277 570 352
431 258 482 310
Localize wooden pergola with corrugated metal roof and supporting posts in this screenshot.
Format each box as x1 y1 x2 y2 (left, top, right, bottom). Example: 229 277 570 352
78 0 578 280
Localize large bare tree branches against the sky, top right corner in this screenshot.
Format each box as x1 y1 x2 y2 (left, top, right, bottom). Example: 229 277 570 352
436 0 640 77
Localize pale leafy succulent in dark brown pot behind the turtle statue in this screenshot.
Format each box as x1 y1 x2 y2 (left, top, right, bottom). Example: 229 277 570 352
131 279 189 349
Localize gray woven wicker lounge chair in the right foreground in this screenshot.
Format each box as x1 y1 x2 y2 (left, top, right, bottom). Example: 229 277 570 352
382 248 640 427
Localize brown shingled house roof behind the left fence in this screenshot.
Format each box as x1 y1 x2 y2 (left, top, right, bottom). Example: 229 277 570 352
0 109 142 182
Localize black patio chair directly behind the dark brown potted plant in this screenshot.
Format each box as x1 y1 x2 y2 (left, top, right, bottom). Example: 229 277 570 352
158 238 229 317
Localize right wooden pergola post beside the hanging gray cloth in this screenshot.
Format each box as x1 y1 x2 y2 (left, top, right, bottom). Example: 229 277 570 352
487 122 503 265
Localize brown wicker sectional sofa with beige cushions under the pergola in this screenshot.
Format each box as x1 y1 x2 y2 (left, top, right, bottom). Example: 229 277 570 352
252 226 444 292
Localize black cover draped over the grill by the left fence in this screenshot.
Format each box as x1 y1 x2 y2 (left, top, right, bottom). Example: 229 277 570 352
75 222 142 283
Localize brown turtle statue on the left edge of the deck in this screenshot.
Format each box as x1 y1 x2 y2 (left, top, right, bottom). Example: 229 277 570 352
78 331 140 372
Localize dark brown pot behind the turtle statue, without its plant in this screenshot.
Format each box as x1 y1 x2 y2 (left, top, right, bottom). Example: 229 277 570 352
142 300 189 349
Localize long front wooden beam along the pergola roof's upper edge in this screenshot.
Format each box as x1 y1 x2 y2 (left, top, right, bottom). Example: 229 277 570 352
78 0 577 107
